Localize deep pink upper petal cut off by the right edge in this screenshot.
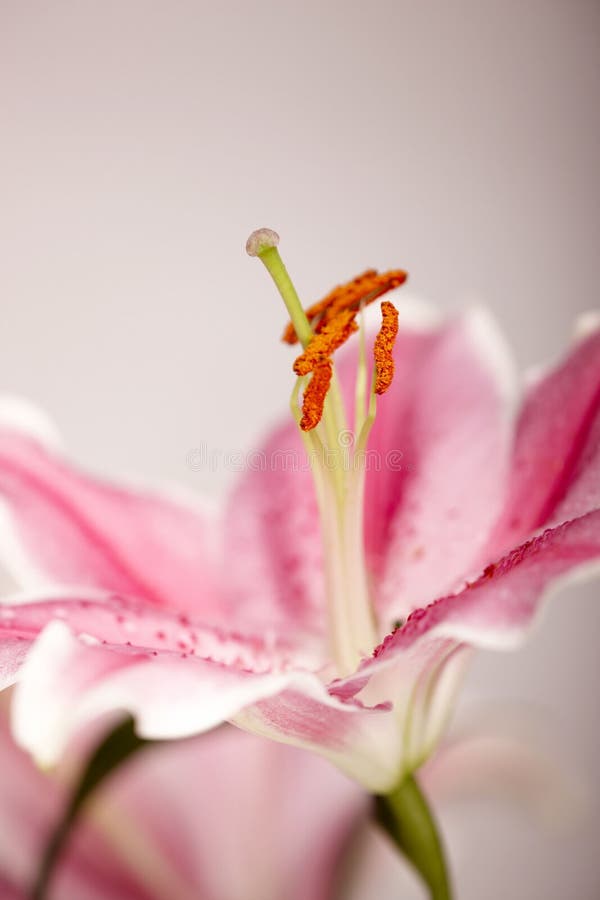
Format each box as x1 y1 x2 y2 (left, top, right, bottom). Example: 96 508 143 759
486 316 600 559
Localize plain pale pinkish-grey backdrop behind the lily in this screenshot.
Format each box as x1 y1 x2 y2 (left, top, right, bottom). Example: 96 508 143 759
0 0 600 900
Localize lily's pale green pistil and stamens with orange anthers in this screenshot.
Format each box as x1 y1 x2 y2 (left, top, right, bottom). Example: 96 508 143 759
246 228 407 675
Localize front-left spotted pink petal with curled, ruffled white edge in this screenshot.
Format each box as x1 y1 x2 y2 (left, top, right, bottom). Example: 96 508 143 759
0 595 317 760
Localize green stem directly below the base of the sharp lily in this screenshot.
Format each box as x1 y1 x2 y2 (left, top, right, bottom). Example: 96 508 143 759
375 775 452 900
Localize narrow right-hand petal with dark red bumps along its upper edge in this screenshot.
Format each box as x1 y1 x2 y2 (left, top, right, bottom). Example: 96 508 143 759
331 511 600 771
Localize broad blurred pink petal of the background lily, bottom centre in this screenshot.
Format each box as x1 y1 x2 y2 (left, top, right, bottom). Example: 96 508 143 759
112 728 366 900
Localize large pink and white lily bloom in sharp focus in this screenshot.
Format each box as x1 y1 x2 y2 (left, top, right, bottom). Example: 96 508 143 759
0 230 600 794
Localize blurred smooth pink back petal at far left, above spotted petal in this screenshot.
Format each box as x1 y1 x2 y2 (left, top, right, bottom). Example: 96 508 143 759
0 421 220 619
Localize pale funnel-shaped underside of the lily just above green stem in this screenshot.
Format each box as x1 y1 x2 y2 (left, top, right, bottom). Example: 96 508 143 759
233 640 468 794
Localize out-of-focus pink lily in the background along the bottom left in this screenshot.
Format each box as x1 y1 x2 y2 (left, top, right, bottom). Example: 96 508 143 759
0 696 367 900
